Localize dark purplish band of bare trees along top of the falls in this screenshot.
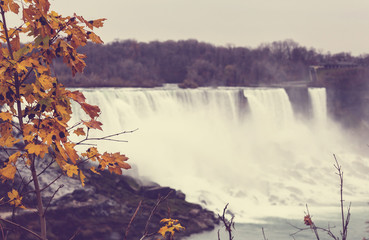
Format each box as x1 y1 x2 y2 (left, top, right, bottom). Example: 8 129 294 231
54 39 369 87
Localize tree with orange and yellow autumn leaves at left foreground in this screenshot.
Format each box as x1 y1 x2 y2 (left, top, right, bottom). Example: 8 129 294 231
0 0 130 239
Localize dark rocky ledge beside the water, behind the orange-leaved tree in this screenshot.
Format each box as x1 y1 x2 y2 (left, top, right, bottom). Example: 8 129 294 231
2 172 219 240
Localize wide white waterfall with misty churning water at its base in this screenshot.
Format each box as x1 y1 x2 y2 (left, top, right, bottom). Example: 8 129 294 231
72 88 369 227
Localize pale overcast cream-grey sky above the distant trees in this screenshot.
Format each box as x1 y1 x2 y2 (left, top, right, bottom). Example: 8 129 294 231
46 0 369 55
